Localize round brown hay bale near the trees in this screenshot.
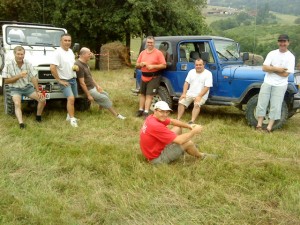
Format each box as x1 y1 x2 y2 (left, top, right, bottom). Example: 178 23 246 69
100 41 131 70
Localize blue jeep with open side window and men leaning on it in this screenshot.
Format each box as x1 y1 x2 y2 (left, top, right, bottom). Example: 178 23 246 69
133 36 300 129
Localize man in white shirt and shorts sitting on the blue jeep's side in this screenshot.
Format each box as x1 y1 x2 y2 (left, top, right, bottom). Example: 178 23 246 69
177 58 213 124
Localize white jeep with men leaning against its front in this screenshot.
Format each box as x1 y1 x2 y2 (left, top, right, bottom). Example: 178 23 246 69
0 21 90 115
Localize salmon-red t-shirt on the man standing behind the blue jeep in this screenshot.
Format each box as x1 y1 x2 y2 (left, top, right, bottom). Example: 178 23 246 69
137 48 166 82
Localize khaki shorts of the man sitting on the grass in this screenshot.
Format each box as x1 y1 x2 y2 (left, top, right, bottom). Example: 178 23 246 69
150 143 184 164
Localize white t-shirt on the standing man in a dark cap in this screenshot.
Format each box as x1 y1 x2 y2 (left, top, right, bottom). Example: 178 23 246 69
263 49 295 86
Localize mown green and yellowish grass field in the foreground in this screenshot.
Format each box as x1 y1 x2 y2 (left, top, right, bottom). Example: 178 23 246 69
0 69 300 225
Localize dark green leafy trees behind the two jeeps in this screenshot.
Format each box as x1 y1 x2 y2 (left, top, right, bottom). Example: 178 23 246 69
0 0 208 68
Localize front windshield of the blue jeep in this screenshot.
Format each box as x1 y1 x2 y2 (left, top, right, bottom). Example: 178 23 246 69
214 40 240 61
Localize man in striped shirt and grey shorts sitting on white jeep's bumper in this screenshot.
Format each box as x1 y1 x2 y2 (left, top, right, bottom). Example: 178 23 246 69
2 46 45 129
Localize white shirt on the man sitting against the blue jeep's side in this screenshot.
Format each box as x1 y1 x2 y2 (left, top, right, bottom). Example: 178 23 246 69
185 69 213 100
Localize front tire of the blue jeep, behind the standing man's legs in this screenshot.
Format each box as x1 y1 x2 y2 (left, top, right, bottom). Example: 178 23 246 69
246 95 288 130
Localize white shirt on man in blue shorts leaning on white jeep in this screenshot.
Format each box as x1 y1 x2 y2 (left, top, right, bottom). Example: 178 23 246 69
51 47 76 80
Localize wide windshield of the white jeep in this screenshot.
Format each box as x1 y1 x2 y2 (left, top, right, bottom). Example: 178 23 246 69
6 26 65 47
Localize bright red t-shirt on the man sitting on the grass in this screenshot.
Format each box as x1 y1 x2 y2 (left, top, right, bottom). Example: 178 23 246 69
140 115 177 160
